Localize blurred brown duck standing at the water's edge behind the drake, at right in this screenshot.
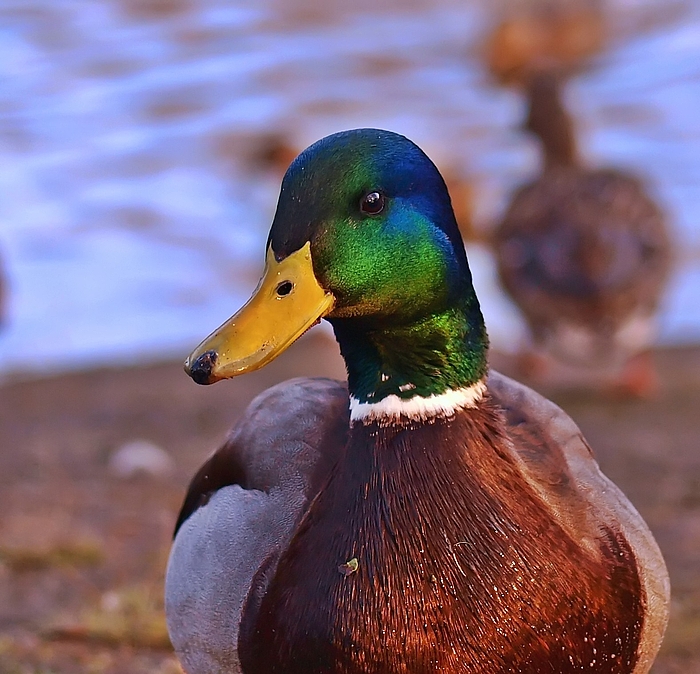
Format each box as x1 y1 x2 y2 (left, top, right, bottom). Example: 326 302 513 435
494 72 671 395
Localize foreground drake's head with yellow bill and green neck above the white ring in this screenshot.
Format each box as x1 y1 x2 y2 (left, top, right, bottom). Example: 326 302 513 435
187 129 487 402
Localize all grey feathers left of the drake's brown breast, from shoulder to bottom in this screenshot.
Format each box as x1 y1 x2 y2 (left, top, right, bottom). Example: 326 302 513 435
165 379 348 674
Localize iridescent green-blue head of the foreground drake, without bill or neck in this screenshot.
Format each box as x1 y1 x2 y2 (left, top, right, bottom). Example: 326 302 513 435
269 129 471 325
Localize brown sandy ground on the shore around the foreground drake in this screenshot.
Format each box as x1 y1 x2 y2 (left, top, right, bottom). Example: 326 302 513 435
0 334 700 674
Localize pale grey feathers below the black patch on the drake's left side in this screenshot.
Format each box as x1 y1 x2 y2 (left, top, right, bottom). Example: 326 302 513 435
165 485 296 674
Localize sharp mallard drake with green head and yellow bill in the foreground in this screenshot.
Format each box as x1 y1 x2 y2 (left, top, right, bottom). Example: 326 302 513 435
166 129 669 674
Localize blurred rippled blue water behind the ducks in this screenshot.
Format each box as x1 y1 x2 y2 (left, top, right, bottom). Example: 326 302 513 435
0 0 700 371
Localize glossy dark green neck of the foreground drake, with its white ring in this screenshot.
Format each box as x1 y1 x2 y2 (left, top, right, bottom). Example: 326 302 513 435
331 291 488 416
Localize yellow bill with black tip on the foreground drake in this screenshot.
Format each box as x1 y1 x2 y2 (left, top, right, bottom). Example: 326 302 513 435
185 243 334 384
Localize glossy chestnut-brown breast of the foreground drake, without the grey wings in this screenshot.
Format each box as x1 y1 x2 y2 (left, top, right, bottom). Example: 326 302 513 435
239 378 644 674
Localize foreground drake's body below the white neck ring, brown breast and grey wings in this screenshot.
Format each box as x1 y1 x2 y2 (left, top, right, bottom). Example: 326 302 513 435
166 372 668 674
